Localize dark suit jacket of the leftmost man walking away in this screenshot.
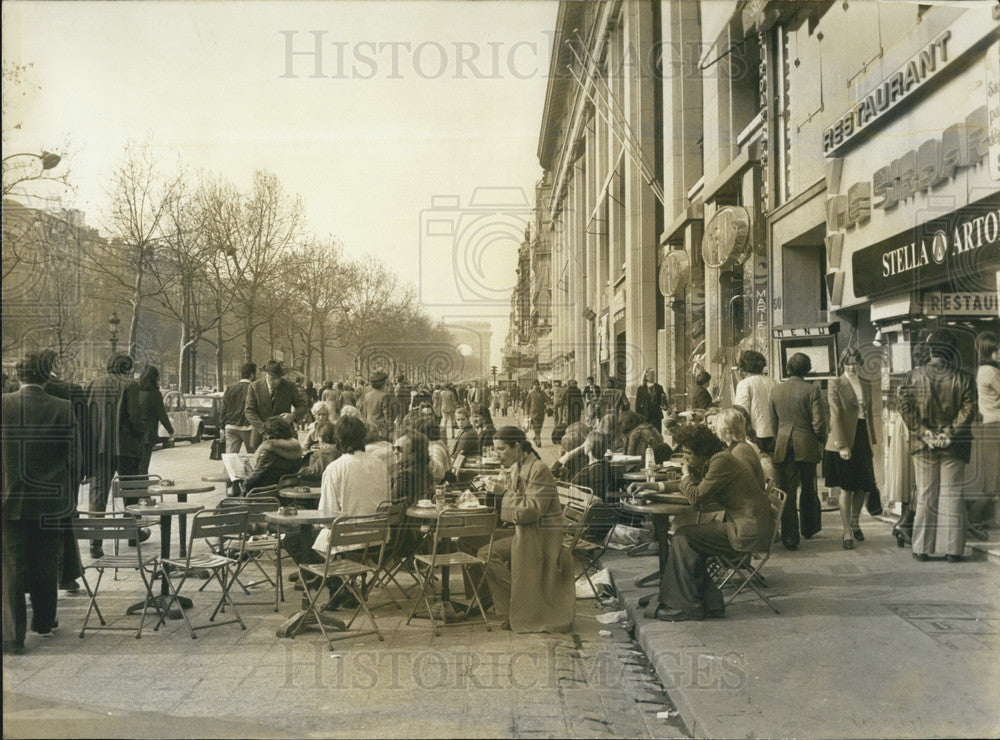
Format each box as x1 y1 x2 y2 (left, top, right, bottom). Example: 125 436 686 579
2 385 81 521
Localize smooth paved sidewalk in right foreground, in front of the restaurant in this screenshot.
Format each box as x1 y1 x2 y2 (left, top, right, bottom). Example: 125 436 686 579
607 512 1000 738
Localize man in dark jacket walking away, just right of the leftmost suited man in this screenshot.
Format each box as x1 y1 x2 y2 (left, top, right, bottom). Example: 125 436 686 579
86 354 143 558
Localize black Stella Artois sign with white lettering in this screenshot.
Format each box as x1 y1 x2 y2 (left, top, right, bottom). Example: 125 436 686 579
851 193 1000 297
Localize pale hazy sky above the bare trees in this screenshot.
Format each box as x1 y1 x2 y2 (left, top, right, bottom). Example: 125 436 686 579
2 0 557 364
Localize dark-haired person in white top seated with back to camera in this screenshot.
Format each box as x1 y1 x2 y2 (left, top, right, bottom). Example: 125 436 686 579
313 416 390 610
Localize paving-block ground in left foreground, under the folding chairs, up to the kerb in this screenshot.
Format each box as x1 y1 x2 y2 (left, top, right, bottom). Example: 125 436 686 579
3 428 686 738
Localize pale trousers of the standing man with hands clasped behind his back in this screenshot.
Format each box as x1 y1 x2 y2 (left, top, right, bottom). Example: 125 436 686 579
913 451 965 555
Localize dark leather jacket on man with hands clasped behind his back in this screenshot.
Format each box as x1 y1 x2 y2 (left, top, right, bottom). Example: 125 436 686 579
899 361 976 462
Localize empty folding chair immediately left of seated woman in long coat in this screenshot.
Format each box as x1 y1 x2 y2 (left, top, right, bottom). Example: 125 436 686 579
406 509 497 636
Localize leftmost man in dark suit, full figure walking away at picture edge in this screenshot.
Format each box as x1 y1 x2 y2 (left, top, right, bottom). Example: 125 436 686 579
2 353 80 653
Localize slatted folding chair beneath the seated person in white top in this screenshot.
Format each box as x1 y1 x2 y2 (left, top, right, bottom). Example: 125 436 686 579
291 512 389 650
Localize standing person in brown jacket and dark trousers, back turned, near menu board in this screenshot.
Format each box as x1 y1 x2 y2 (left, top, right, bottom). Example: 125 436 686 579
771 352 826 550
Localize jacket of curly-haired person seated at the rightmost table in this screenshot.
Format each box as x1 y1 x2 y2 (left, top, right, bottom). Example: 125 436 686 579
680 451 775 552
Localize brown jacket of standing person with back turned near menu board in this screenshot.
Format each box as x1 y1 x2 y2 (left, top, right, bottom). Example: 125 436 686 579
771 377 826 465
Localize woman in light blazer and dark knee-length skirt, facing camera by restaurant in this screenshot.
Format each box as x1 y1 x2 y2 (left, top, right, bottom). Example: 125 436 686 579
823 347 876 550
